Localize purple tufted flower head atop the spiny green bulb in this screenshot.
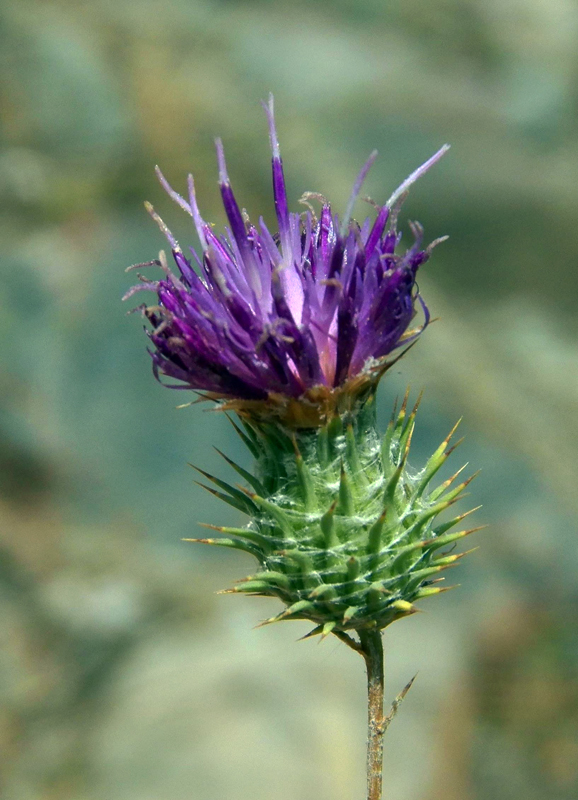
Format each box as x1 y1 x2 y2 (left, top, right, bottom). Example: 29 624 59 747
125 97 448 422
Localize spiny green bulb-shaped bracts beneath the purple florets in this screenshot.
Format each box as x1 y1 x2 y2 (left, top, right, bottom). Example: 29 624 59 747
187 392 477 635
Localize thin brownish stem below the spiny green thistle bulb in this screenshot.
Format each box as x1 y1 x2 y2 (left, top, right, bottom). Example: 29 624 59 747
359 631 384 800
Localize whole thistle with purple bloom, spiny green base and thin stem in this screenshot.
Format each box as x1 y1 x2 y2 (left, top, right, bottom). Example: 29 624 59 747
126 99 475 800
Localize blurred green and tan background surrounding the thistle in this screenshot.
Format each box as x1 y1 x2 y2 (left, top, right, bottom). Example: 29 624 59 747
0 0 578 800
